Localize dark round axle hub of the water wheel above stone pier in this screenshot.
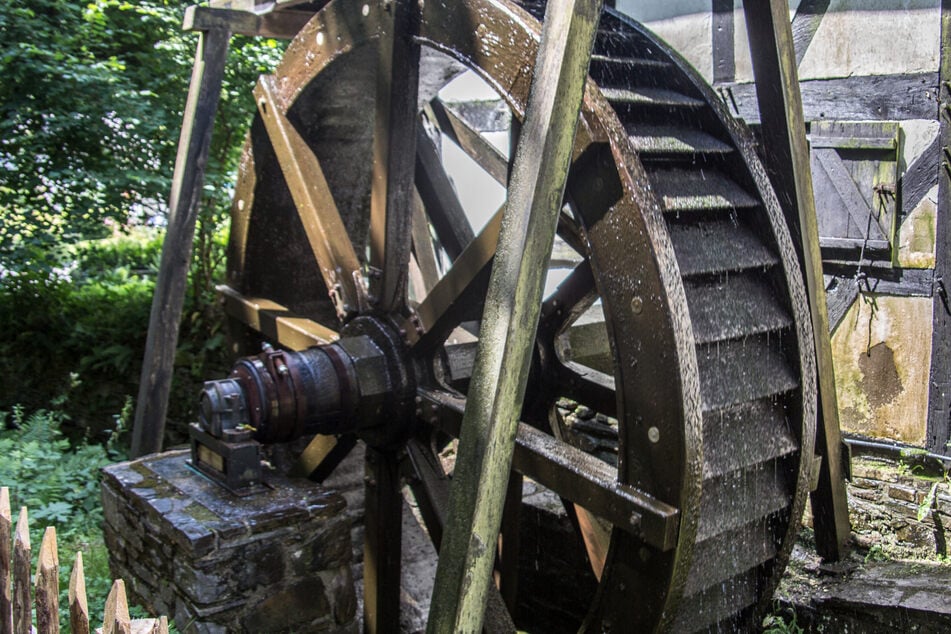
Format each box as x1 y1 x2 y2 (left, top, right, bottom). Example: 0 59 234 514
199 317 415 448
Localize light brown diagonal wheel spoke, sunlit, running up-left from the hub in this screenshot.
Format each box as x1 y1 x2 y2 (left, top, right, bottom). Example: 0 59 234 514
254 75 363 317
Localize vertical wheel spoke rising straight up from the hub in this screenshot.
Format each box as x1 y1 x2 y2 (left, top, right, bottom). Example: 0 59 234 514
368 0 419 312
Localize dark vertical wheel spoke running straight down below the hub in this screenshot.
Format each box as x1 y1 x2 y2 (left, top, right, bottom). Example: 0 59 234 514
363 447 403 634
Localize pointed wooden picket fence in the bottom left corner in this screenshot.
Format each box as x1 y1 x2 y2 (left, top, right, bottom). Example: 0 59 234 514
0 487 168 634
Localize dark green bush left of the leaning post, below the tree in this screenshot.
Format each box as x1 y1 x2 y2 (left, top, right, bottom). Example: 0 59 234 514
0 230 161 432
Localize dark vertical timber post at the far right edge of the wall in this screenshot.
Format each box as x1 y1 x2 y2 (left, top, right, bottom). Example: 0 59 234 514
927 0 951 456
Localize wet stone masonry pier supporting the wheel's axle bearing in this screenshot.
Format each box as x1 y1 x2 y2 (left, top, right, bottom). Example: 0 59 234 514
102 451 358 634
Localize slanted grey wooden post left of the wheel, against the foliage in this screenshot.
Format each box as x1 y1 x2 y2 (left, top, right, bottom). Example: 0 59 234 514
132 24 231 457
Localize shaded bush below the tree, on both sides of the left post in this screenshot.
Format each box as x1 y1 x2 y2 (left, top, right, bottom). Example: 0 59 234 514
0 228 229 440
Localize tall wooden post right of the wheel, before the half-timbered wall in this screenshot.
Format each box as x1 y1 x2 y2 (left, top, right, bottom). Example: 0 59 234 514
743 0 851 561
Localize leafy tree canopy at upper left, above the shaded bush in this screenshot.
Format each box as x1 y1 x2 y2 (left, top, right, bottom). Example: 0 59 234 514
0 0 282 256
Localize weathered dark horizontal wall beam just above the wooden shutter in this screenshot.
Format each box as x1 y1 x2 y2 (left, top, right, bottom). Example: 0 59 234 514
718 73 938 123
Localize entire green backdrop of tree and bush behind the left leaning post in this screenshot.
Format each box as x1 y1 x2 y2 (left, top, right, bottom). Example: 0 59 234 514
0 0 283 431
